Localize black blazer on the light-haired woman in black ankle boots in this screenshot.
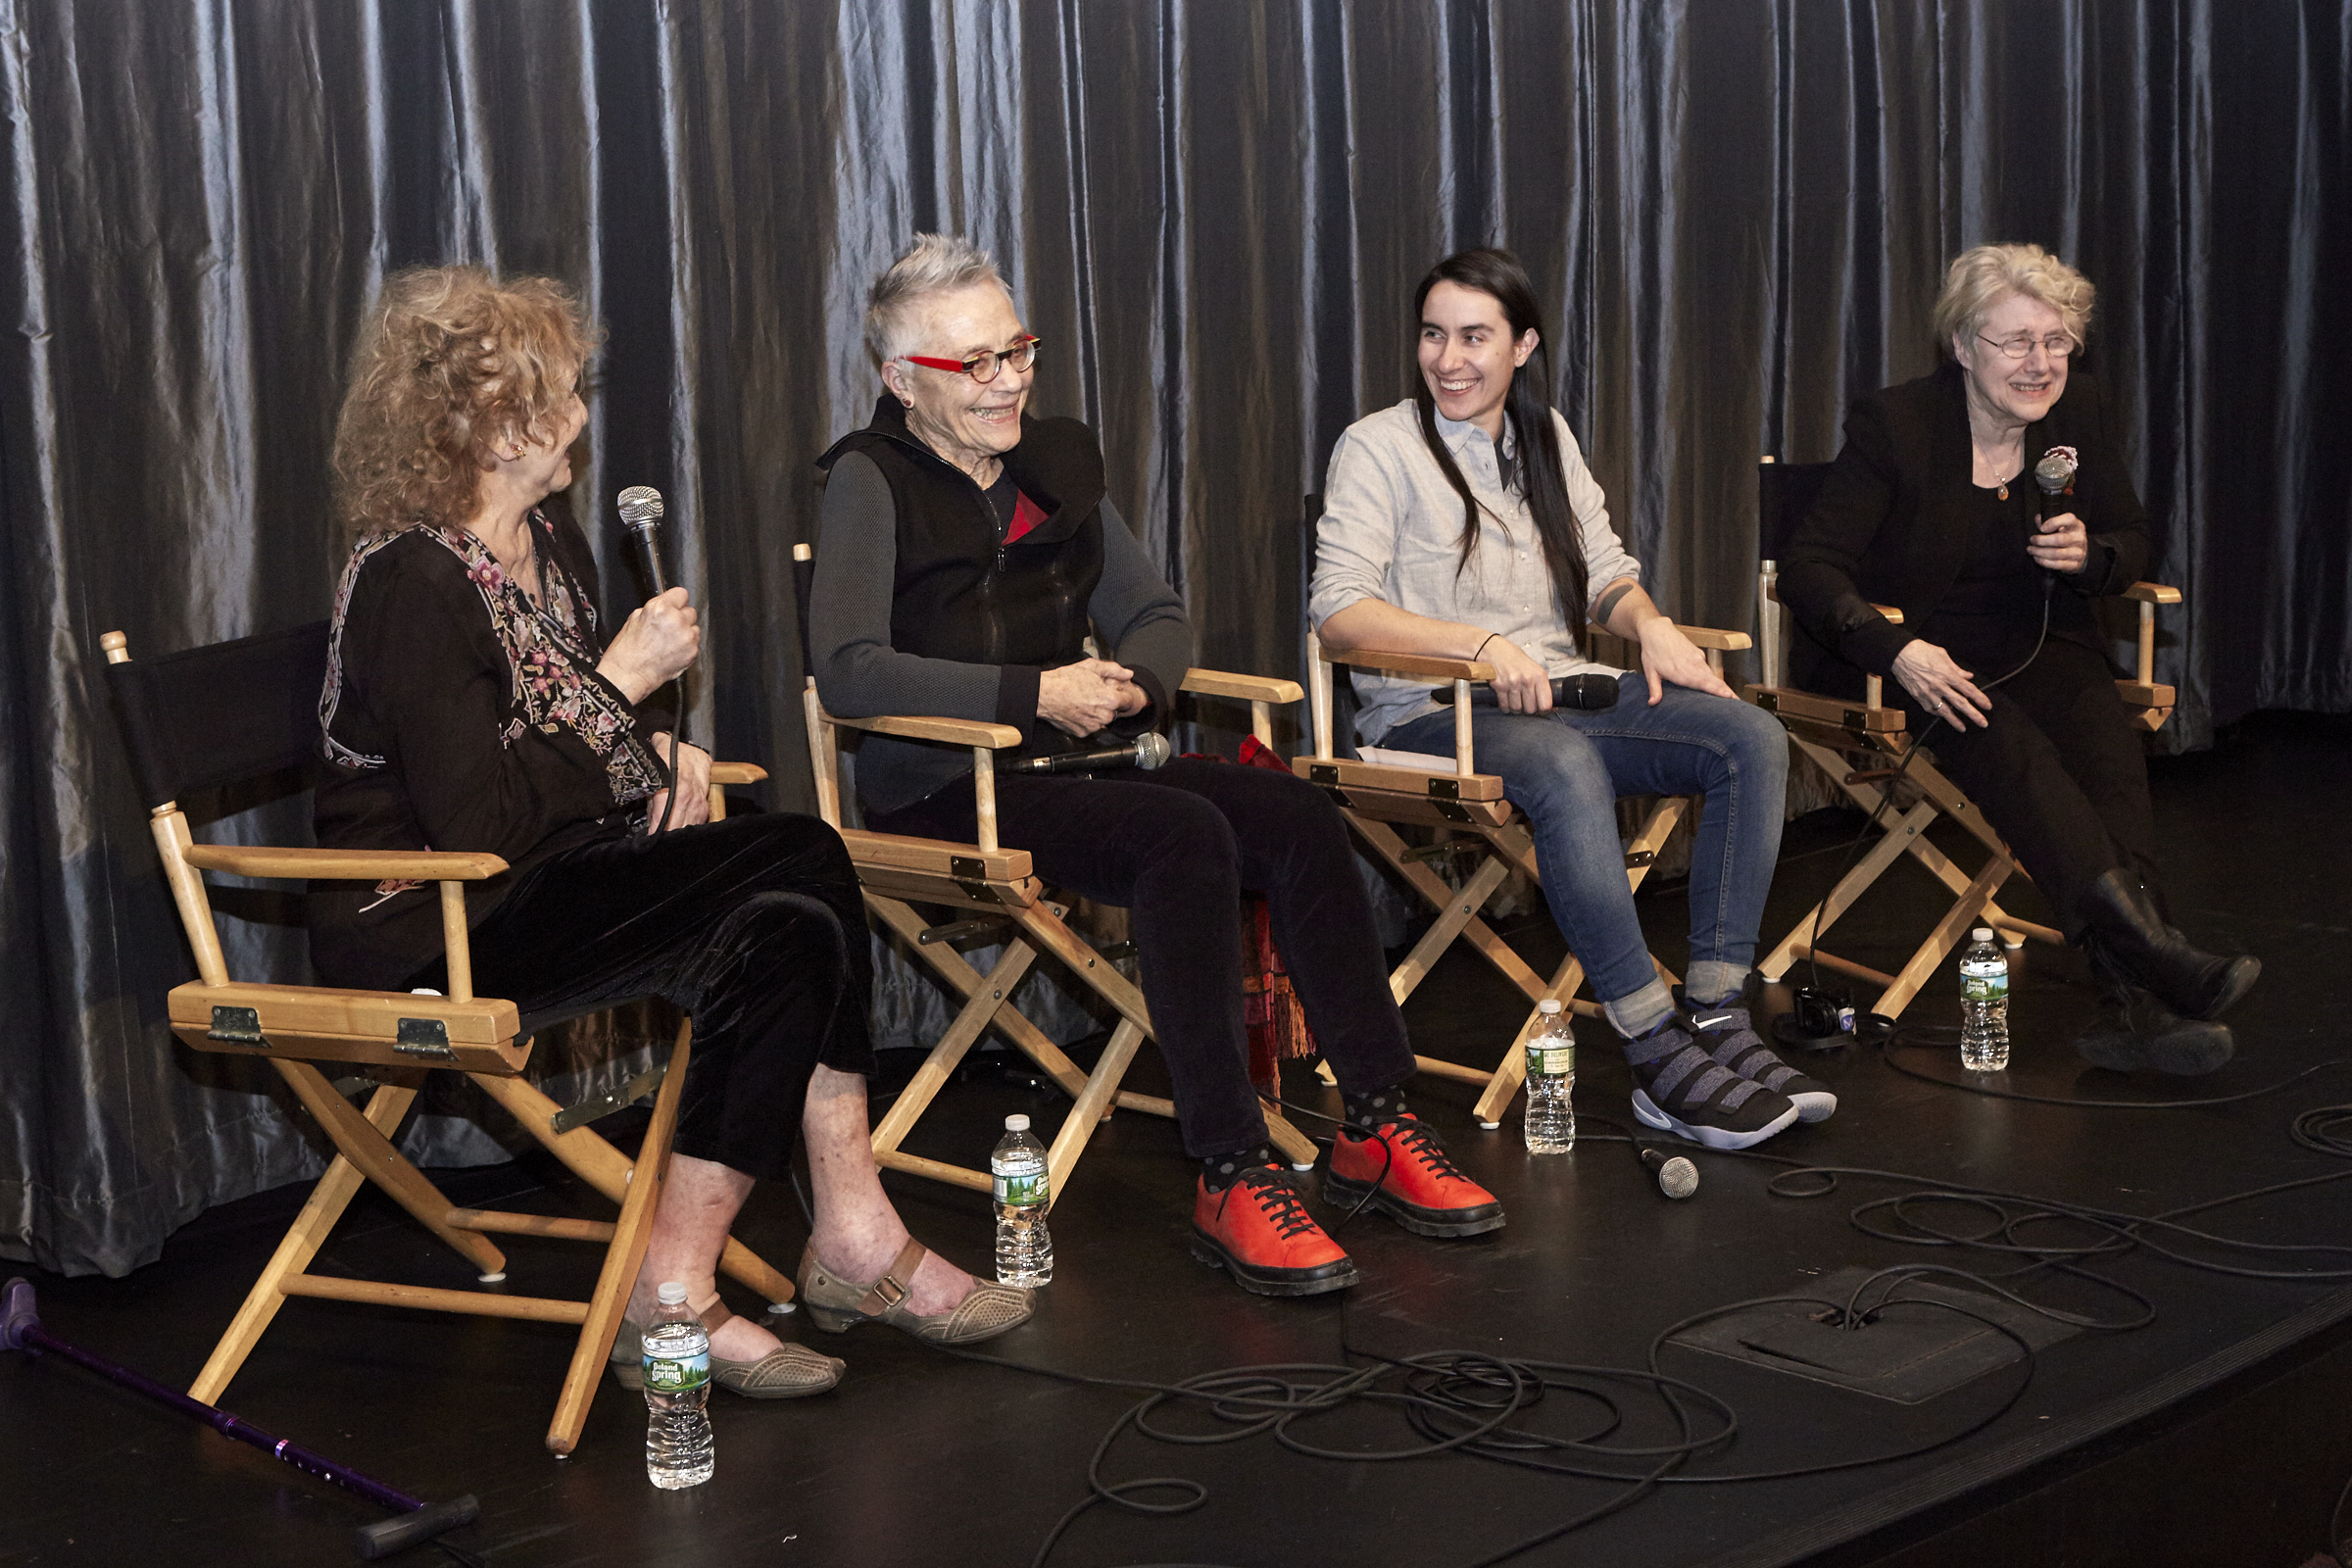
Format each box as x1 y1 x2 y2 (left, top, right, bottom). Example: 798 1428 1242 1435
1781 362 2150 696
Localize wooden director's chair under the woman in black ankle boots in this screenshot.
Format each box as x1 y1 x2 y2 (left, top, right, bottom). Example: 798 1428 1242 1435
1742 456 2180 1018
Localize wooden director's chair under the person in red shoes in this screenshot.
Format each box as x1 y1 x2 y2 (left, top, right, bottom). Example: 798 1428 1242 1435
793 543 1315 1203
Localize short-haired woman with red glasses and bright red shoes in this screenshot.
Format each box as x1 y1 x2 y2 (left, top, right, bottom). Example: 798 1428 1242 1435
805 235 1503 1296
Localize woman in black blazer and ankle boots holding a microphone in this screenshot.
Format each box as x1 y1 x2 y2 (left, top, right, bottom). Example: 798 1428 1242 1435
1781 244 2260 1074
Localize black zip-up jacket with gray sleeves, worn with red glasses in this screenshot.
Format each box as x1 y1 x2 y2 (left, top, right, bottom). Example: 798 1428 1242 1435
809 395 1193 811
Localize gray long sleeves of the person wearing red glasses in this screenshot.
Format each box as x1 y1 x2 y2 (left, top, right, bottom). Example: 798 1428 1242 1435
809 452 1193 813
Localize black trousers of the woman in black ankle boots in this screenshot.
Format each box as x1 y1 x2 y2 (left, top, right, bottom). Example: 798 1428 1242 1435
1888 637 2157 943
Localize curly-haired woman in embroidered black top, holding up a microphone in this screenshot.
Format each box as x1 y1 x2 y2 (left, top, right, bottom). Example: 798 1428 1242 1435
311 268 1030 1398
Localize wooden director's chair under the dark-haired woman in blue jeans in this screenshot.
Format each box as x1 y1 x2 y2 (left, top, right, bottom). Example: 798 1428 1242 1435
1292 625 1747 1131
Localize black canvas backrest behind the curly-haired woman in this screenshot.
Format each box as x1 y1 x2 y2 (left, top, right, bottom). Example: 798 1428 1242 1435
106 620 327 807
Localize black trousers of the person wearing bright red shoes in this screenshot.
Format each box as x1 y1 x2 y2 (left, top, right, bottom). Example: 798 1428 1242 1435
870 760 1413 1156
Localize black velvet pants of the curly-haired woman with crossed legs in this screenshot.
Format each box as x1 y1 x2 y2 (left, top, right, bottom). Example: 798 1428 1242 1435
412 815 872 1180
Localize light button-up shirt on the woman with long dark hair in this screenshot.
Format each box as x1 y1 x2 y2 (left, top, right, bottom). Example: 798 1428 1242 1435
1307 397 1642 745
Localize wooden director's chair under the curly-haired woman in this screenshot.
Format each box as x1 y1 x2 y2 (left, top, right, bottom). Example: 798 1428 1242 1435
99 620 793 1455
